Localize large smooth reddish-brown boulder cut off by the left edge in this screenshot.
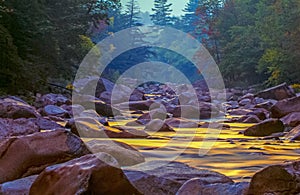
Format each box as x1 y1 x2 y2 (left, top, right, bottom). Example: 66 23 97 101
0 130 89 183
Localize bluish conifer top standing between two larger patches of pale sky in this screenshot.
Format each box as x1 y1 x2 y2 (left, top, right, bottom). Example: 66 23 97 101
150 0 173 26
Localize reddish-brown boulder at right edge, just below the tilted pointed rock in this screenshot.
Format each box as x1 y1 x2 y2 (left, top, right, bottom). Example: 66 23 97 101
271 97 300 118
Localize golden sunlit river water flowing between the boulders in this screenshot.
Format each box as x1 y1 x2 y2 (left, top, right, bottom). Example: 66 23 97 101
85 121 300 181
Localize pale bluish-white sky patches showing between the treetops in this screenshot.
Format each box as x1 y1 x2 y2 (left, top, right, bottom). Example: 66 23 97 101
121 0 188 16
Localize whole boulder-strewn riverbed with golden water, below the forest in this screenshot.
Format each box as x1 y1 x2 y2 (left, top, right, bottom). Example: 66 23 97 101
0 78 300 195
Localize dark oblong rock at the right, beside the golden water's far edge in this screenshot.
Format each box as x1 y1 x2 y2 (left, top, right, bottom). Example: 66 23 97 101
244 119 284 136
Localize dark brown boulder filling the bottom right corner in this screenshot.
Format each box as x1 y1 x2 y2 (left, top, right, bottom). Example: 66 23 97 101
248 161 300 195
